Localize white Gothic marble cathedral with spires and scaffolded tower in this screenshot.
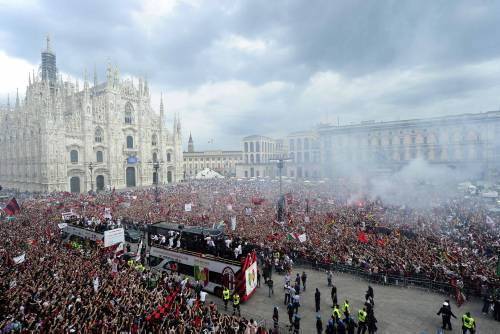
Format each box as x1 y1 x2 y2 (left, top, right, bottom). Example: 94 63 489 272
0 38 183 193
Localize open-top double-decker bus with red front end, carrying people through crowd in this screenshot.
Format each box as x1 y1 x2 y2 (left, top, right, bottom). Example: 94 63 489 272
147 222 257 301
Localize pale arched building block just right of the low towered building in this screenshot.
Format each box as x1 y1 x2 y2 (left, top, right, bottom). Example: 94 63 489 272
236 135 286 178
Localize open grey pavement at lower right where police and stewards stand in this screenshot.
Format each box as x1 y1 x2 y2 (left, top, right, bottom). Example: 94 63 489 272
209 267 500 334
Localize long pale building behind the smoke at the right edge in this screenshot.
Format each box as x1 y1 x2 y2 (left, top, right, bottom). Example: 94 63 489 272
317 111 500 177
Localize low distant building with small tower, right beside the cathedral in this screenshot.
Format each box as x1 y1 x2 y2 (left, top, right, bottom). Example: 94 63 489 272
183 134 243 179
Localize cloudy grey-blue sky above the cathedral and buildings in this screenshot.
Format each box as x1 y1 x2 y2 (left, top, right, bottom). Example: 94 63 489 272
0 0 500 149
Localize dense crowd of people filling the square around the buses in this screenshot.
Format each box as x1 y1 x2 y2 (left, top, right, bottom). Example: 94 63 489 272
0 180 500 333
